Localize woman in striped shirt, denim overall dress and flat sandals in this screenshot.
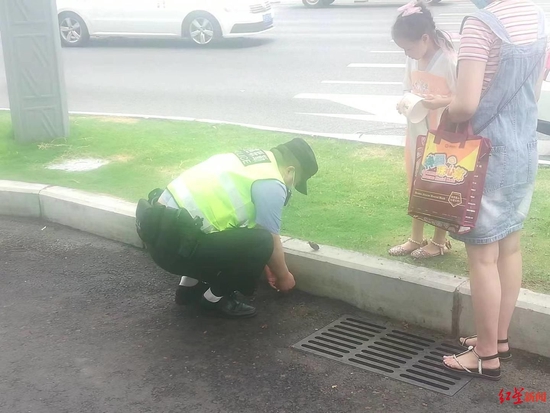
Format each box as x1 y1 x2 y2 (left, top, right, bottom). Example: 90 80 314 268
443 0 547 380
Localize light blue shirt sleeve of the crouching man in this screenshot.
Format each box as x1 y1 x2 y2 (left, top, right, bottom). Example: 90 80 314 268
252 179 286 234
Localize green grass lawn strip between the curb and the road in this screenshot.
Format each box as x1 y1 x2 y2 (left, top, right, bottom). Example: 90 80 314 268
4 113 550 292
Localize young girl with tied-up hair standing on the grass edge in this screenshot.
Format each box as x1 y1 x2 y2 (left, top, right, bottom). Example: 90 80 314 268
389 0 457 259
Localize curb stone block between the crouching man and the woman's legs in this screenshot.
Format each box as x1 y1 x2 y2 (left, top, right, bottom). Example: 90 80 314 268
284 240 465 333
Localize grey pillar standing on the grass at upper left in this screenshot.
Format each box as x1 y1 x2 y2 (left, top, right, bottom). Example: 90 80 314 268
0 0 69 142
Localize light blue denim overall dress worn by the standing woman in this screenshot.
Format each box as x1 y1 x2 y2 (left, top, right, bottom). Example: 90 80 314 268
451 10 547 245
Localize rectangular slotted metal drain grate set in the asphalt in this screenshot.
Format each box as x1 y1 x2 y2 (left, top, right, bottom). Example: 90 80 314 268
292 316 471 396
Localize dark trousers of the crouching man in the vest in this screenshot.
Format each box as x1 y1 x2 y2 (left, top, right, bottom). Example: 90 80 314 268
148 228 273 297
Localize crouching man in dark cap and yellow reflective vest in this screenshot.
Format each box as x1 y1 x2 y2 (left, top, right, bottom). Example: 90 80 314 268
136 138 318 318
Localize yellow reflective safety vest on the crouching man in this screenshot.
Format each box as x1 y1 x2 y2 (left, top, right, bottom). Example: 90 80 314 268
167 149 284 233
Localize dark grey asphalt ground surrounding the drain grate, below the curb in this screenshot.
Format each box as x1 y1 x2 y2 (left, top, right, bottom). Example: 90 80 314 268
0 217 550 413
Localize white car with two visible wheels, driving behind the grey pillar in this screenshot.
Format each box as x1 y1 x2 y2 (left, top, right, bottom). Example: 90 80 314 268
57 0 273 46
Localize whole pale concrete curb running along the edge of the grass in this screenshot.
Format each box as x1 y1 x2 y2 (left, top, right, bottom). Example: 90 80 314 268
0 181 550 357
